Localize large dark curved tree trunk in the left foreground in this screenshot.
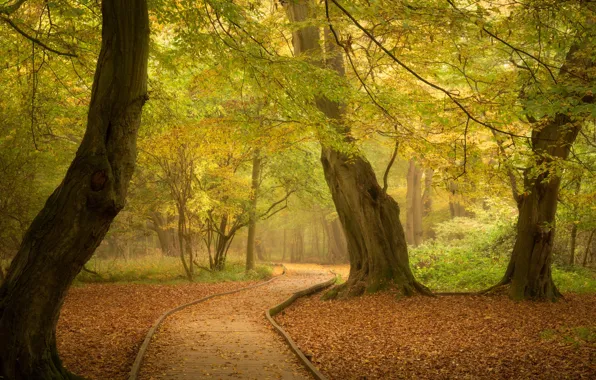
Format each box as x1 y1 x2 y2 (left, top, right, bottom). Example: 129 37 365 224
0 0 149 379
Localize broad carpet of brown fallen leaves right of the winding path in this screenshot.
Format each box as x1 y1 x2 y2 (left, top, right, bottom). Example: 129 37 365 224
276 293 596 379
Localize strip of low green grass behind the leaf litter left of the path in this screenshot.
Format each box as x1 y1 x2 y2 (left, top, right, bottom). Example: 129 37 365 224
75 255 273 284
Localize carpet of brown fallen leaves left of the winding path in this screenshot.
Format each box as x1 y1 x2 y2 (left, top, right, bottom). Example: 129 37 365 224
56 282 254 379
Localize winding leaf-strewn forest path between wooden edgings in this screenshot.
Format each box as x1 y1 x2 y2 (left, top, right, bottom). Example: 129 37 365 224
139 264 333 380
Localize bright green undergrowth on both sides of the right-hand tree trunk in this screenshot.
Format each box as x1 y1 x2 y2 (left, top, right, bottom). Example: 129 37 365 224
410 216 596 293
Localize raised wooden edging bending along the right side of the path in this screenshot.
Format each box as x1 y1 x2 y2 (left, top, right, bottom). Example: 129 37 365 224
265 272 338 380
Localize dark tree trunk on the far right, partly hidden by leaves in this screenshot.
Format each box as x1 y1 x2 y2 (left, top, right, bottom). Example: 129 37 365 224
497 27 594 300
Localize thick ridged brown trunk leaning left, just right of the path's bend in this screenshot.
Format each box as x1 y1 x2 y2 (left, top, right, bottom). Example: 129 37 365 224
285 0 428 296
